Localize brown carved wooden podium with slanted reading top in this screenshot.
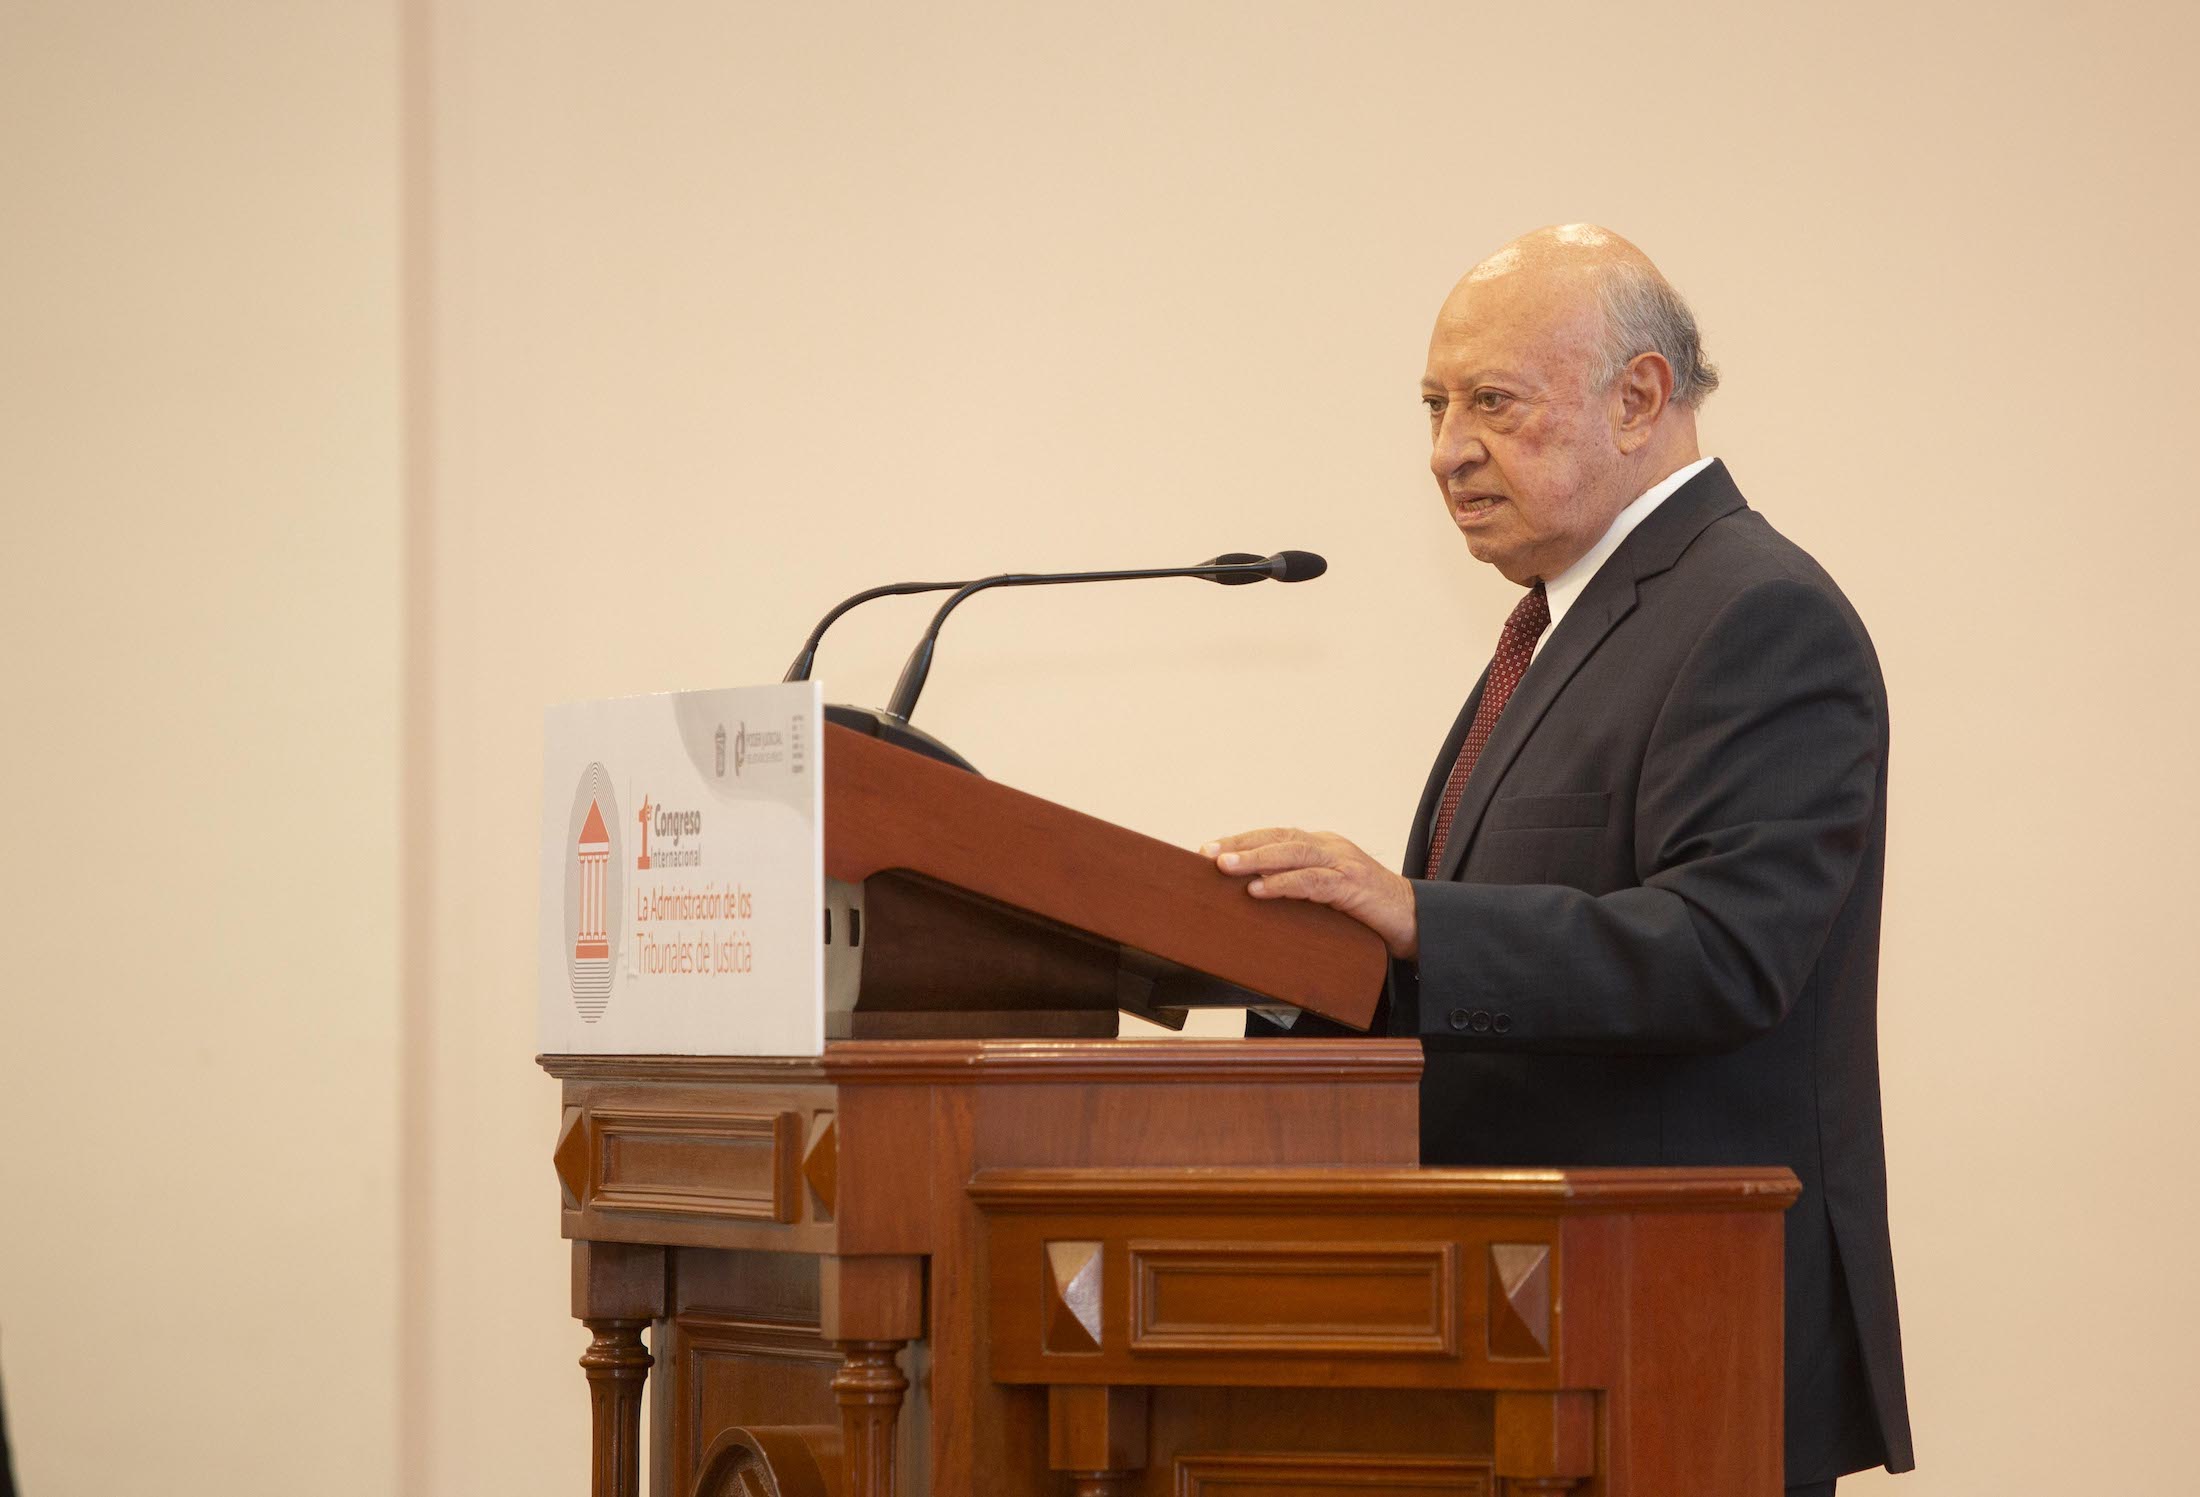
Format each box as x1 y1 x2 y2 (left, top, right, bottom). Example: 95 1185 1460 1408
541 729 1795 1497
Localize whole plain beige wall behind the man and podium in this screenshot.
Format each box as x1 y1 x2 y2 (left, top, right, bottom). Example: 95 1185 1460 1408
0 0 2200 1497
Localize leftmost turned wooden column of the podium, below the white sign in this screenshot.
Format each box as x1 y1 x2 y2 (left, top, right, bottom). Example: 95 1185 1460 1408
572 1242 664 1497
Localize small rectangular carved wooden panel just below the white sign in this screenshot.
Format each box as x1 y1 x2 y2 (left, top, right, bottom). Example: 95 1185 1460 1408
587 1110 801 1222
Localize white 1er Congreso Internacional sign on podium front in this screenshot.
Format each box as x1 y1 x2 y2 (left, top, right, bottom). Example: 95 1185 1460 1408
539 680 825 1055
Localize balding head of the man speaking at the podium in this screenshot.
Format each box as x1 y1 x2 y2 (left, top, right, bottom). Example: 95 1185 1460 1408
1421 225 1718 583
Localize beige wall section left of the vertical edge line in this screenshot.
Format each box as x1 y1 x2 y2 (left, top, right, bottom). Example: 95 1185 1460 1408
0 0 403 1497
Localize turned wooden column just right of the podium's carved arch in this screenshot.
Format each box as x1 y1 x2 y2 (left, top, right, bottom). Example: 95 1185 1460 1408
818 1257 924 1497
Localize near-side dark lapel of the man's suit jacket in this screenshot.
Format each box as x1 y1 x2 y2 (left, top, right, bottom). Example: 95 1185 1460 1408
1434 462 1745 878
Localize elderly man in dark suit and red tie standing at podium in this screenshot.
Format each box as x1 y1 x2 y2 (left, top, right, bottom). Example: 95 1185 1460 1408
1208 225 1912 1493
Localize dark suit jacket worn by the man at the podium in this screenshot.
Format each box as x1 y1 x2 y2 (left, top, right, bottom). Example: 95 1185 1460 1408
1256 462 1912 1484
